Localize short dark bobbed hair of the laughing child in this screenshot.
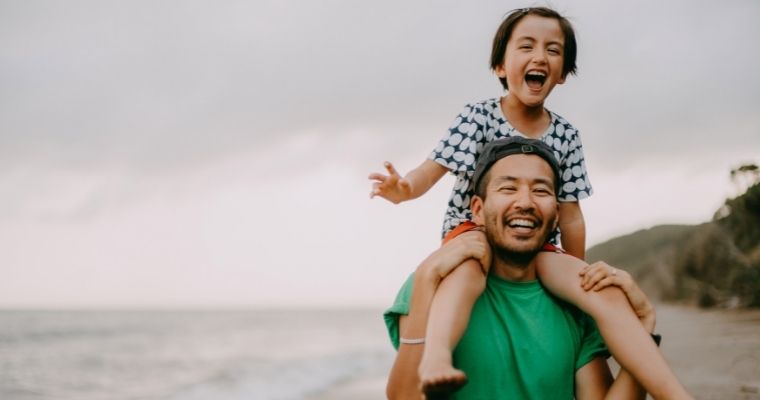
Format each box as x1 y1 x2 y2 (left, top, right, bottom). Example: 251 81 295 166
491 7 578 90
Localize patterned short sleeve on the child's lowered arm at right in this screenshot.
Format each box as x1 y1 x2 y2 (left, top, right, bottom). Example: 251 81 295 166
555 124 594 202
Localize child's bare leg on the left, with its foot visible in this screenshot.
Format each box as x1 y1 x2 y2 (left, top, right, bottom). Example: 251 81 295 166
419 259 486 397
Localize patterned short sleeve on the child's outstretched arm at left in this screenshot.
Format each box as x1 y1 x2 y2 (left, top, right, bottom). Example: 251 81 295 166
428 104 486 173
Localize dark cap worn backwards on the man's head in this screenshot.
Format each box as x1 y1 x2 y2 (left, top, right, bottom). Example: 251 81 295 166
472 136 560 194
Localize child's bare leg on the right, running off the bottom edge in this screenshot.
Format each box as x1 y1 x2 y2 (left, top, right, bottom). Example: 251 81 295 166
537 252 691 399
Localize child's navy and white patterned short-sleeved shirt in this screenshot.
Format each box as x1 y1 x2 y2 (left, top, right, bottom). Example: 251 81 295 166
428 98 593 236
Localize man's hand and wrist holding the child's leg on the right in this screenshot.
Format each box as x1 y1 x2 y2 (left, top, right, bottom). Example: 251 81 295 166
578 261 655 331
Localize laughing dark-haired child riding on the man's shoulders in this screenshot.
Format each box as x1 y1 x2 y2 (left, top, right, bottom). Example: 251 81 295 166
370 7 688 398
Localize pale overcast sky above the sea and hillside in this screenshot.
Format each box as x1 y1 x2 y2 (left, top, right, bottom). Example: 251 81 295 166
0 0 760 308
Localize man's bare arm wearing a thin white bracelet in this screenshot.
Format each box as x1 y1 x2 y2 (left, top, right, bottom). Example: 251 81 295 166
386 231 491 400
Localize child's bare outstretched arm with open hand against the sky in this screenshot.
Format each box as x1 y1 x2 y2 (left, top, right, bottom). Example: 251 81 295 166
369 160 448 204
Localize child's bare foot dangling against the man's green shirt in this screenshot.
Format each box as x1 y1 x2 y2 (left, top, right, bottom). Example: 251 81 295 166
419 351 467 400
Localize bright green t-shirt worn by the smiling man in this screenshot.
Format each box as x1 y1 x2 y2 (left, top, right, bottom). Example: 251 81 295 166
384 275 609 400
